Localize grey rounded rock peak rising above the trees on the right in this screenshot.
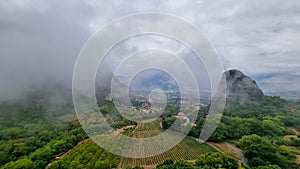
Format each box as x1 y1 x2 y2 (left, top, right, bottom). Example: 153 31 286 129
225 69 264 103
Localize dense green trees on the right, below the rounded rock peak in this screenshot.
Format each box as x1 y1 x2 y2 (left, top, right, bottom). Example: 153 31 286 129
180 96 300 168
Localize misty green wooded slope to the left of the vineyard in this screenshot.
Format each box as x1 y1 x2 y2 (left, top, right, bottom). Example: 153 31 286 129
0 98 86 169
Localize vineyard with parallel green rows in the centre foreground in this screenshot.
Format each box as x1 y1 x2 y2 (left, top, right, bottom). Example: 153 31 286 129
48 121 216 169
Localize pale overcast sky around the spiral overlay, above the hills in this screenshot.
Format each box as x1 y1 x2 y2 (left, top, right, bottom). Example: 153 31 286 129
0 0 300 99
